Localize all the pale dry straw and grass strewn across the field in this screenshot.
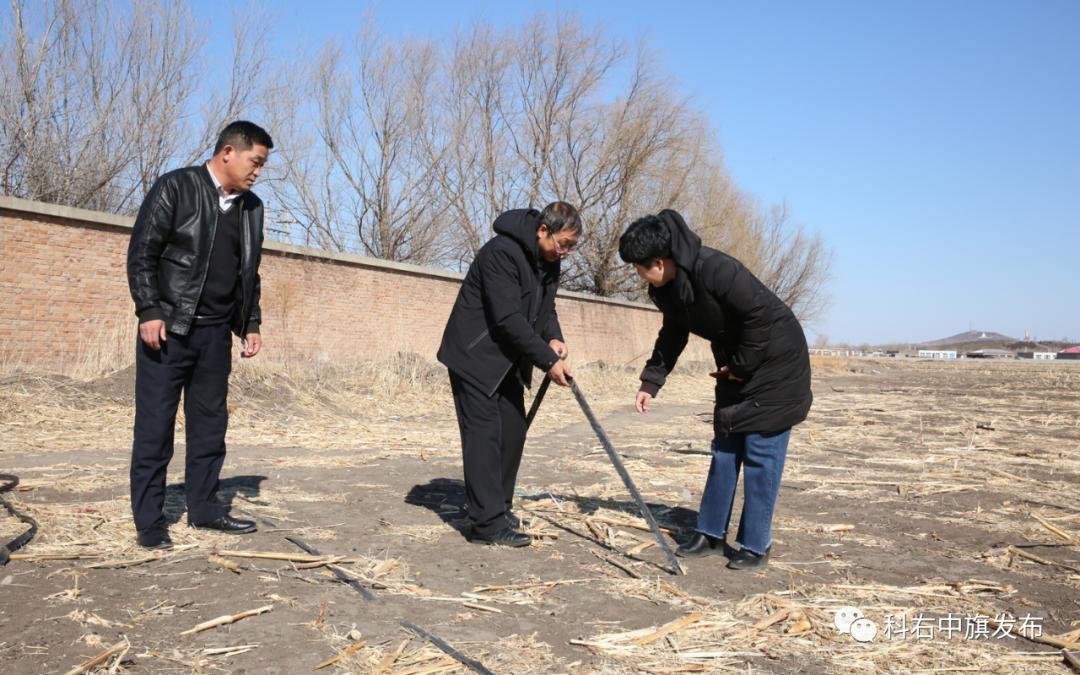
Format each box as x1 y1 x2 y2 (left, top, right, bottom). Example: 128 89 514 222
0 355 1080 675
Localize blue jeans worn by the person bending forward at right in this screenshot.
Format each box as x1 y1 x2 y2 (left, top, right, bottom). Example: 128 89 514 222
698 429 792 555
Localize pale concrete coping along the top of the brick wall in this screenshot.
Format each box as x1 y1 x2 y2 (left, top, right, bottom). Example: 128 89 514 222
0 195 657 312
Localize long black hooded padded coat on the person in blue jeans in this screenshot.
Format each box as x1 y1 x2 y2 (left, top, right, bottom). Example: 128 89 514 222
642 210 813 433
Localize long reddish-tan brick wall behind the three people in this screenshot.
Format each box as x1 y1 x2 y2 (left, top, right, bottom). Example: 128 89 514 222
0 198 710 373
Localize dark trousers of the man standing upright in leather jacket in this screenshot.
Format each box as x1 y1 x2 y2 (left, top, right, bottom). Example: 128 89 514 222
131 323 232 529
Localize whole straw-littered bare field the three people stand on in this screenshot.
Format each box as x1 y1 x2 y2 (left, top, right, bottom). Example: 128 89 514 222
0 357 1080 675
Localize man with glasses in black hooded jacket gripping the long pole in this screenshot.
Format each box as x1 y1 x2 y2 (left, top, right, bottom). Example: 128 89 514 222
438 202 581 546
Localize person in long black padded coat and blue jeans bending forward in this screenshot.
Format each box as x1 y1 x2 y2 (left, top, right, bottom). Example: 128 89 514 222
619 210 813 569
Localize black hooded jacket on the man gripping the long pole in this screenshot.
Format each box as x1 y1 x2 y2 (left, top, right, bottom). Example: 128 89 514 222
438 208 563 396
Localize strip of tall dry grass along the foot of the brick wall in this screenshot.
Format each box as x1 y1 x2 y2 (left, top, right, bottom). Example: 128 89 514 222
0 352 712 453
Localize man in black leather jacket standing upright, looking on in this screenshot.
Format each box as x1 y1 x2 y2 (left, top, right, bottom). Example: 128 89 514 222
127 121 273 549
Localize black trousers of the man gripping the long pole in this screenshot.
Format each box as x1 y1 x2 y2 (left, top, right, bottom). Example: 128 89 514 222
450 373 526 535
